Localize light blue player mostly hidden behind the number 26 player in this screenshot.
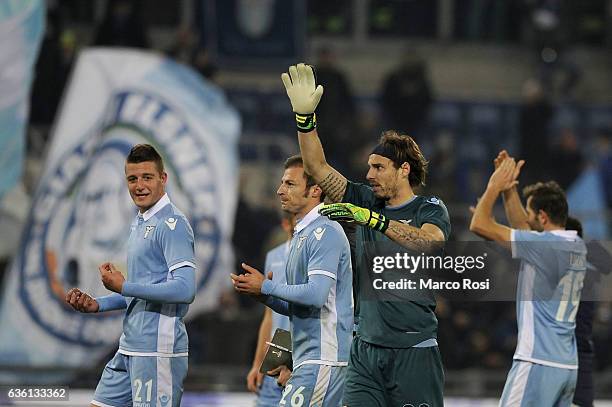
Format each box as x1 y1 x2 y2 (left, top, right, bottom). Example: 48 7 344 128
247 211 294 407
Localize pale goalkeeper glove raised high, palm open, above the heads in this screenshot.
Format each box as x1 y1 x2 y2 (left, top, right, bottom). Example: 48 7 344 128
281 64 323 133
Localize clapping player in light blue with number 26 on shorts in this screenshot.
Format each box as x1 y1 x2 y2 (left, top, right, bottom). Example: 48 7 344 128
231 156 353 407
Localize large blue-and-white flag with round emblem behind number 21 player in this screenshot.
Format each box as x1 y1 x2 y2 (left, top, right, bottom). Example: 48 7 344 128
0 49 240 381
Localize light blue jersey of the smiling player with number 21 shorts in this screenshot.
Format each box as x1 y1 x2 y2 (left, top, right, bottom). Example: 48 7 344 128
119 195 195 357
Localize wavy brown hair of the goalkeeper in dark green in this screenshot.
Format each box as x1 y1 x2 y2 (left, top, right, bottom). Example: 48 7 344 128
379 130 429 187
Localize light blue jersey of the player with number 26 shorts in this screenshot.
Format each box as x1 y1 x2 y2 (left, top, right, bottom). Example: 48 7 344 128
286 206 353 371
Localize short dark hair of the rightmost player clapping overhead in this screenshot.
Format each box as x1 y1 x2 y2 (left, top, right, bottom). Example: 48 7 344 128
523 181 568 227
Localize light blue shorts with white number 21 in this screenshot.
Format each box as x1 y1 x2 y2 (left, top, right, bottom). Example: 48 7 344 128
91 352 187 407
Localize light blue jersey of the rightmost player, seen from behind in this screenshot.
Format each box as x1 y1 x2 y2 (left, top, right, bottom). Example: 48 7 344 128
512 230 586 369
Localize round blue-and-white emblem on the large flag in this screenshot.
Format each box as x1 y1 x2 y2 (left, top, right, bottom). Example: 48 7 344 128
16 90 223 349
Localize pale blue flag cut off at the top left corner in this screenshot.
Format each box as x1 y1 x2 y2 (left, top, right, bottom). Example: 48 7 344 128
0 0 45 197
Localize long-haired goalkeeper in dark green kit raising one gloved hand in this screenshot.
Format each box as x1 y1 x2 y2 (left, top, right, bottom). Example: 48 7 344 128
281 64 450 407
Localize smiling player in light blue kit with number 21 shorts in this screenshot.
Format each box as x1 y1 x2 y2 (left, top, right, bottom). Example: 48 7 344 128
66 144 196 407
